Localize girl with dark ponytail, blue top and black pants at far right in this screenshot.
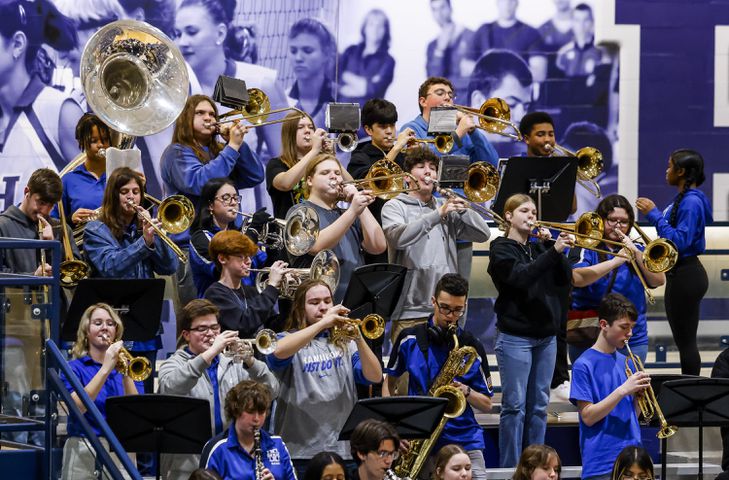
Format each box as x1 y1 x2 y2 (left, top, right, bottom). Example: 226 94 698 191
635 149 714 375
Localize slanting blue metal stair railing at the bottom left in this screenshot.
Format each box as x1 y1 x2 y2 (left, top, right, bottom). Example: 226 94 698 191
44 340 142 480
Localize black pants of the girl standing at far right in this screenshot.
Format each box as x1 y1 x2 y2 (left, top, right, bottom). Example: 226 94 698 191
664 257 709 375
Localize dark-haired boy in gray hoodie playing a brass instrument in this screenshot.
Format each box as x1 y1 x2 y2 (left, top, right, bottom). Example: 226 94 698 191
382 147 490 342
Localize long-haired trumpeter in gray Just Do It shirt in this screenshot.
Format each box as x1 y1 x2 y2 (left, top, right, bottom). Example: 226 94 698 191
267 280 382 475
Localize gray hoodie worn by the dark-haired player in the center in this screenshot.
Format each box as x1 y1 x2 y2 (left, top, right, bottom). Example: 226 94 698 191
382 193 491 320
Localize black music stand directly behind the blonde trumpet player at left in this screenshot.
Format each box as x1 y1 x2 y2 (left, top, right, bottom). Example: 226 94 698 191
61 278 165 341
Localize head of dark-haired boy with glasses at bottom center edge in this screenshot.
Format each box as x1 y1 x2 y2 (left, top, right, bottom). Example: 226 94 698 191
349 418 400 480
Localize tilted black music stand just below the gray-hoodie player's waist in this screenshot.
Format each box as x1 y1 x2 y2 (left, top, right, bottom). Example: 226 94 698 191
342 263 408 320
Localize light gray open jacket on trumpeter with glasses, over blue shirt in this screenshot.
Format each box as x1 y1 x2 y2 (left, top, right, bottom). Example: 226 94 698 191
157 348 279 480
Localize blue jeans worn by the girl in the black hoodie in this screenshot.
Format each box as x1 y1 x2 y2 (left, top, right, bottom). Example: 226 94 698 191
495 332 557 468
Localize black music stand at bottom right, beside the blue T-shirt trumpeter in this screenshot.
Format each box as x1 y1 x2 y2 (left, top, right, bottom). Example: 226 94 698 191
658 377 729 480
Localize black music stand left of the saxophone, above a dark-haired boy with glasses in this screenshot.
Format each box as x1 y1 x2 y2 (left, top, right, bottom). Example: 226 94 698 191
339 396 448 440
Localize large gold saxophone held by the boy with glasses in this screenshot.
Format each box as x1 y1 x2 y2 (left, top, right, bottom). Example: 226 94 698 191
393 325 478 479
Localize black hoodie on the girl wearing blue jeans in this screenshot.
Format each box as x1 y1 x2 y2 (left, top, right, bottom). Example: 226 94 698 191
488 237 572 338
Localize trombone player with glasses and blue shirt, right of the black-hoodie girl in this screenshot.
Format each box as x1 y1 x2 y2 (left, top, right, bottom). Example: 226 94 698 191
569 195 666 364
